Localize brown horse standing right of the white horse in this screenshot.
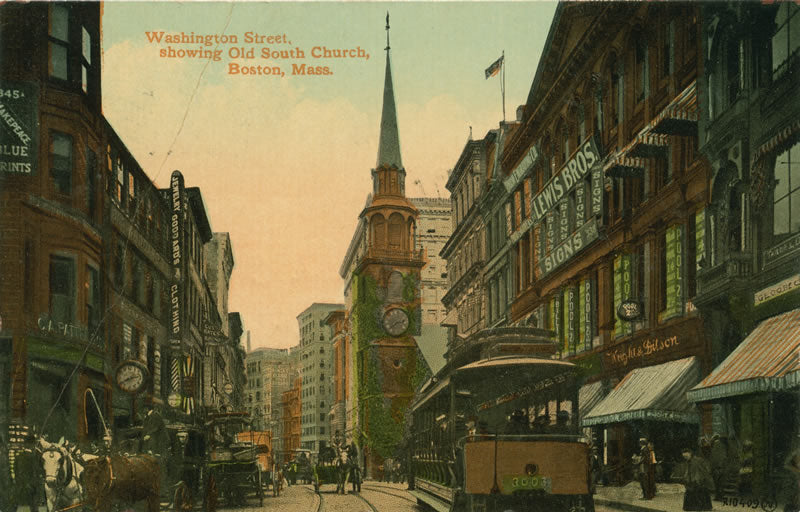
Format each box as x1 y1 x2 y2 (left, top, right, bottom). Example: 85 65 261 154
83 455 161 512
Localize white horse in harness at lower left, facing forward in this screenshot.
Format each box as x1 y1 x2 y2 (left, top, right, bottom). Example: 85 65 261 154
38 438 95 512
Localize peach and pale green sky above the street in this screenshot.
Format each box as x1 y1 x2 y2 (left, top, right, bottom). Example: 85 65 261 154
102 2 556 348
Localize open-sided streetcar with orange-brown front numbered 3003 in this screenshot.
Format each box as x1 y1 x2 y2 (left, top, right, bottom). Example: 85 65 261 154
410 327 594 512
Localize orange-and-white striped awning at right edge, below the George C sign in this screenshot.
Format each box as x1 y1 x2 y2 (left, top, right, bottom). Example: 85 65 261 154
687 309 800 402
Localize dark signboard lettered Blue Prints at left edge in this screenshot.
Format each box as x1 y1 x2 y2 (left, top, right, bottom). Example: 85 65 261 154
0 80 39 176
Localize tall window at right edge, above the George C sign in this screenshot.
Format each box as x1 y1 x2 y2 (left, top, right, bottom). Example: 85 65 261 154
772 141 800 237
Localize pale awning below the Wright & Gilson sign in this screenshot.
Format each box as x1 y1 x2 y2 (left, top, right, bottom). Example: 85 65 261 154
581 357 700 427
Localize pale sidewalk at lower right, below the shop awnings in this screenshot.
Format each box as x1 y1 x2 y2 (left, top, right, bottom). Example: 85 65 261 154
594 482 783 512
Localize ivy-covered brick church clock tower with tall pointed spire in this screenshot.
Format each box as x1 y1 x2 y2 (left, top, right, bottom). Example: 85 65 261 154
349 13 428 477
